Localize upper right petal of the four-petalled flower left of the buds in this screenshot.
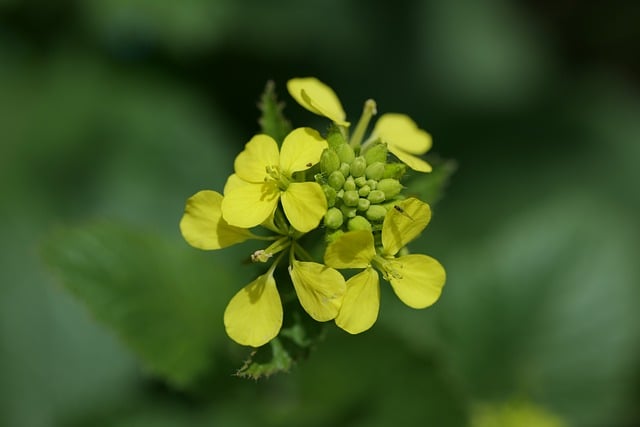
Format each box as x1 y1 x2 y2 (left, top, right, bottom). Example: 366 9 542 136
280 128 327 176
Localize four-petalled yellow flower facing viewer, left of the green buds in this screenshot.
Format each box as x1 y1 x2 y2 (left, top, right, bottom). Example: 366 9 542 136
222 128 327 232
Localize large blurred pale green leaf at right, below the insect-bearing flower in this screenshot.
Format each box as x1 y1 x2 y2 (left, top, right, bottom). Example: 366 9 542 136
392 195 640 426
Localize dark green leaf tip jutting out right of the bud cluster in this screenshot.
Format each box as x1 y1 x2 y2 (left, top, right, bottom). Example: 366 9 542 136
404 158 458 206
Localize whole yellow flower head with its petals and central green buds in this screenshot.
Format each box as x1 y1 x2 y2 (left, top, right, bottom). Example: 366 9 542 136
180 78 445 347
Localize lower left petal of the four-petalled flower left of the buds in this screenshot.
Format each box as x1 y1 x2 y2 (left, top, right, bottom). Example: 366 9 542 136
222 181 280 228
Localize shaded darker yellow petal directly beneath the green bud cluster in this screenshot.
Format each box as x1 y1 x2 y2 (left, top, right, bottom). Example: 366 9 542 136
324 230 376 268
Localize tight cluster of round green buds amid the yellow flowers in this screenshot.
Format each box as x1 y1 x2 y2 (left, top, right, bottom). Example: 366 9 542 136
316 133 405 237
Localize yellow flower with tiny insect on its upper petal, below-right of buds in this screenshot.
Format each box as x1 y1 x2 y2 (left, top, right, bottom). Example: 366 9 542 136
324 198 446 334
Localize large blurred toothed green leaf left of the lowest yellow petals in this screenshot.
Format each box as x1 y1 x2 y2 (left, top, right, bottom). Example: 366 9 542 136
44 223 232 388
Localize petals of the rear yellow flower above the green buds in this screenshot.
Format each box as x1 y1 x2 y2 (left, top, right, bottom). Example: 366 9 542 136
287 77 432 172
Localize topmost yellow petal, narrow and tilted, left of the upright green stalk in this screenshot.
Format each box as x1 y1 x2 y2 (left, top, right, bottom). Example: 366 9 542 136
287 77 349 126
